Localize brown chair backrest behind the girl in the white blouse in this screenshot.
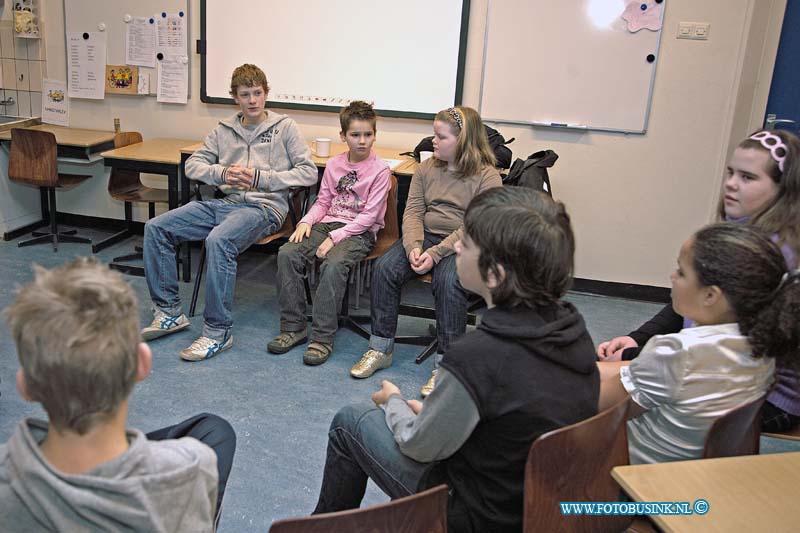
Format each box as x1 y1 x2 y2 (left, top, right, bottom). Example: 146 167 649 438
703 395 766 459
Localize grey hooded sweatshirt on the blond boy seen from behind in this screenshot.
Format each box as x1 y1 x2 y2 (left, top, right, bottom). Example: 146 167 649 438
0 419 217 532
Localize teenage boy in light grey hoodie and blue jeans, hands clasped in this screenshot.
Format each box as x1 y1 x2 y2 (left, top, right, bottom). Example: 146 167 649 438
142 64 317 361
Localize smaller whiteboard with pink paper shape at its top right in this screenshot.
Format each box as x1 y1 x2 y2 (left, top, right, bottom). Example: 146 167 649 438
480 0 667 133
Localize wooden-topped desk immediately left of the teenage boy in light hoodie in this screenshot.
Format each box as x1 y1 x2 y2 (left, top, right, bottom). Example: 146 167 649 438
100 138 197 281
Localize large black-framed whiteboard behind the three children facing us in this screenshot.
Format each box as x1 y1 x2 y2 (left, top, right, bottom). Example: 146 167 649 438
199 0 469 118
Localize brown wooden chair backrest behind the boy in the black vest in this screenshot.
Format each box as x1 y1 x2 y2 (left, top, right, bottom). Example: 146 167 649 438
523 398 631 533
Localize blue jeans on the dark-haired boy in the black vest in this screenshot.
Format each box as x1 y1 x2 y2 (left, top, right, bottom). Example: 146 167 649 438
314 405 433 514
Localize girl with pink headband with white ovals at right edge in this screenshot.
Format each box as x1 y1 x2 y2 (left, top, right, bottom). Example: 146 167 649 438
597 130 800 432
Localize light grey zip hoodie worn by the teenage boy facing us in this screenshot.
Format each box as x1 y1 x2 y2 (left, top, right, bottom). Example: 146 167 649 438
186 111 317 222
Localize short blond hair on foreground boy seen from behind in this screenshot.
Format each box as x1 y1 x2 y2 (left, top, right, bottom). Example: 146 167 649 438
6 258 141 435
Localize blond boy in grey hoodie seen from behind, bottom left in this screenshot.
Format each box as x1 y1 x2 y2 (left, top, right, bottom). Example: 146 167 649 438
0 258 236 532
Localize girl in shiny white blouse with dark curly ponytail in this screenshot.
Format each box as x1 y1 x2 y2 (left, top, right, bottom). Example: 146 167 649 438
598 223 800 464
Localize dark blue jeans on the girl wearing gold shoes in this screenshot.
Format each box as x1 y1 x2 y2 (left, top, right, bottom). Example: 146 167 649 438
369 232 469 366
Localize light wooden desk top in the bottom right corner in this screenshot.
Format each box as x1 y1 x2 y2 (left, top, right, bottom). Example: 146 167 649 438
611 452 800 532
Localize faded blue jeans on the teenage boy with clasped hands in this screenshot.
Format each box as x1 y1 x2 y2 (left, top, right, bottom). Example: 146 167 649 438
144 199 280 340
